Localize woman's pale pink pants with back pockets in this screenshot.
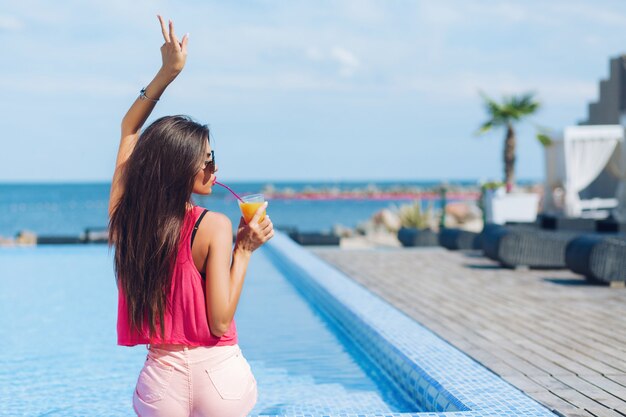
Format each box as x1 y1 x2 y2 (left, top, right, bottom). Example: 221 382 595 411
133 345 257 417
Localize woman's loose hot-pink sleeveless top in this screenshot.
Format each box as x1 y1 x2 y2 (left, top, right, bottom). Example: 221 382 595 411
117 206 237 346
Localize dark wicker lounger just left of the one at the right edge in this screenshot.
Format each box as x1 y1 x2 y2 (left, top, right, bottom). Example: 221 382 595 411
481 224 581 268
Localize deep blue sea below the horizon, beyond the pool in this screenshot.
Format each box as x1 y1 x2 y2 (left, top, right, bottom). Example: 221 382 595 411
0 181 476 237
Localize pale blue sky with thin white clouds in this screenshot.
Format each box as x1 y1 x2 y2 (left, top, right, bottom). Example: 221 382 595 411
0 0 626 182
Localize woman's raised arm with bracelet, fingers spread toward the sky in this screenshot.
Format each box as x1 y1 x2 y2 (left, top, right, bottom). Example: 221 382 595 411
109 16 189 217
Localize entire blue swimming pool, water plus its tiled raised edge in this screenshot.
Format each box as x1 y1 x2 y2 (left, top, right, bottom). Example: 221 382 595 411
0 235 553 417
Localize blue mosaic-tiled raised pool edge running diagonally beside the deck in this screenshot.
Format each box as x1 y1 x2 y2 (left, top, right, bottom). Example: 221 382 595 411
256 233 555 417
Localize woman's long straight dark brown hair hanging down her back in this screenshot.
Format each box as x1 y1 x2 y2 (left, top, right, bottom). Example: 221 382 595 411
109 116 209 338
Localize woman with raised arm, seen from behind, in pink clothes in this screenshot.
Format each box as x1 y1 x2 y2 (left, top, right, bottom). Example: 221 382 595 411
109 16 274 417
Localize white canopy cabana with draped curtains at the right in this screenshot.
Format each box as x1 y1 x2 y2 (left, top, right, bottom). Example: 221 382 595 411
544 125 626 217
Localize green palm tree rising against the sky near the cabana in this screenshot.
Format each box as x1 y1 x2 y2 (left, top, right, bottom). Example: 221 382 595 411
477 93 550 193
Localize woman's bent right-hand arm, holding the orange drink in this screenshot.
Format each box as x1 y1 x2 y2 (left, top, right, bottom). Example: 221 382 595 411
205 206 274 337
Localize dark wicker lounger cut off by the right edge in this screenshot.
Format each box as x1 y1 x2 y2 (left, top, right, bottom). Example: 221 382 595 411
565 235 626 287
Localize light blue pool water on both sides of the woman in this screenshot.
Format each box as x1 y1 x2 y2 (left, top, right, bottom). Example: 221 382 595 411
0 245 419 416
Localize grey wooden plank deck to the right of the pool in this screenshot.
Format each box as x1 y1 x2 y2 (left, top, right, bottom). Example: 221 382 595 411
311 248 626 417
